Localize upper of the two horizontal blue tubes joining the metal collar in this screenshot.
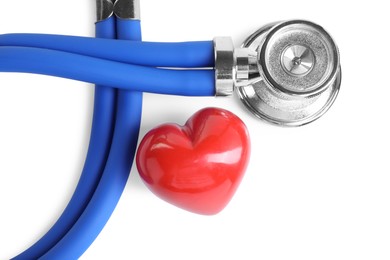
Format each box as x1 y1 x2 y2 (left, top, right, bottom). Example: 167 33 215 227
0 34 214 68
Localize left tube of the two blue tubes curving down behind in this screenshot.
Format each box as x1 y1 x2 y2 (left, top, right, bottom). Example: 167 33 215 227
14 18 116 260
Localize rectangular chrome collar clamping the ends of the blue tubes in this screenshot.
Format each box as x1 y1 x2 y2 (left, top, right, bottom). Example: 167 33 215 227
214 37 235 96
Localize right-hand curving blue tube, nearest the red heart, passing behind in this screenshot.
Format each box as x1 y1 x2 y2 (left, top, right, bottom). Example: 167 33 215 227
41 20 142 260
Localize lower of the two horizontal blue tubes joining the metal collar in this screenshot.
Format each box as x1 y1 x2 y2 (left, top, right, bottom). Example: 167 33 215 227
0 47 215 96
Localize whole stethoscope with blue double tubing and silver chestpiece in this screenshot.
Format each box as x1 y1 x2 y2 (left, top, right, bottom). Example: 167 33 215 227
0 0 341 259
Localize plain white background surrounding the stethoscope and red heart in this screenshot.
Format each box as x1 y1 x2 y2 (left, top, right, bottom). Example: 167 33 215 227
0 0 390 260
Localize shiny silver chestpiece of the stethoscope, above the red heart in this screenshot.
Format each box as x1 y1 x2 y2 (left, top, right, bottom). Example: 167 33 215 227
216 20 341 126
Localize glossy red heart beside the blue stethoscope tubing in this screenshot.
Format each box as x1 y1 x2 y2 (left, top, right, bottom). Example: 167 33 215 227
137 108 250 215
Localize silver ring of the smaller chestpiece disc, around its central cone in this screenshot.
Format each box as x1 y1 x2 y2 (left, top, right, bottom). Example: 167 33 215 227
258 20 340 95
